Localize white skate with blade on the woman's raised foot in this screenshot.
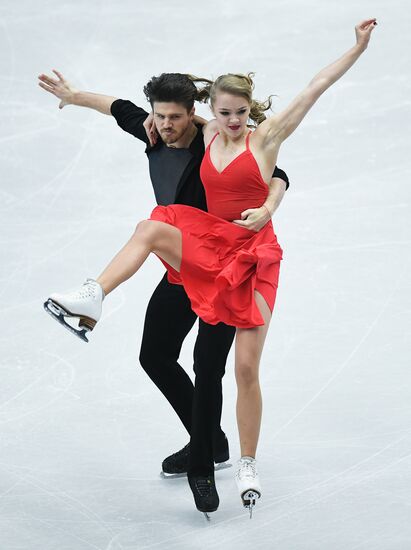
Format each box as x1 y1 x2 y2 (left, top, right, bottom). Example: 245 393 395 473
44 279 104 342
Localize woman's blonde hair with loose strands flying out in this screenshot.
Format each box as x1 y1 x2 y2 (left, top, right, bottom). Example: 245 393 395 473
187 73 272 126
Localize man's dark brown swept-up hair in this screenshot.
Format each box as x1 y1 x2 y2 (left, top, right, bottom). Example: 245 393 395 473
143 73 197 112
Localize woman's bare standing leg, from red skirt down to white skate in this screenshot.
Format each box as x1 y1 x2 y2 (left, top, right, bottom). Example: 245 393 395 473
235 291 271 458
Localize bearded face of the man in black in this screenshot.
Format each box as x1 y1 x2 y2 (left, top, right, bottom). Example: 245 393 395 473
153 101 194 145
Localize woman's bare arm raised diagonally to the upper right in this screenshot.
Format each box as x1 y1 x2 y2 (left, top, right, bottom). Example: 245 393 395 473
257 19 377 147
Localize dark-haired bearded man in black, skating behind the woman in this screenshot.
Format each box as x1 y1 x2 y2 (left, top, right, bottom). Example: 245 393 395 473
39 70 288 513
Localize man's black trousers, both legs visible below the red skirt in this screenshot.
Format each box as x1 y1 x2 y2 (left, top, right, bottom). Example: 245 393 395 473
140 275 235 475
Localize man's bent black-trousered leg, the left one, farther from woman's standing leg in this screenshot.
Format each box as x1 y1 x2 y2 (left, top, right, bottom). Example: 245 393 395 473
140 275 197 433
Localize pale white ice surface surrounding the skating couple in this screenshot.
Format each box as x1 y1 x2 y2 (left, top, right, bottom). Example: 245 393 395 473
0 0 411 550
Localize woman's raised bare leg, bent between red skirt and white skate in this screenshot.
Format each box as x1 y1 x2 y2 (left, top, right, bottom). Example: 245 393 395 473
96 220 182 295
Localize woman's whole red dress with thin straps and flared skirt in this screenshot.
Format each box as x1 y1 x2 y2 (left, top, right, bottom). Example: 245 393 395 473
150 134 282 328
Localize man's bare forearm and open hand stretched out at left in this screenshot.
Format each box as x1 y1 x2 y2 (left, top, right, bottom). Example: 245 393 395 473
39 69 117 115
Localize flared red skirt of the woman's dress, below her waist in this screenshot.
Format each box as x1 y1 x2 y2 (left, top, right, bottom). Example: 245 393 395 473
150 204 282 328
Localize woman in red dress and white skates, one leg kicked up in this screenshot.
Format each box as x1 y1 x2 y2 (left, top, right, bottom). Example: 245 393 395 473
45 19 376 513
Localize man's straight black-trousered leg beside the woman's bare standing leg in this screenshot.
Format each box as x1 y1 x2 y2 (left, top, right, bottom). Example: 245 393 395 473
189 319 236 475
